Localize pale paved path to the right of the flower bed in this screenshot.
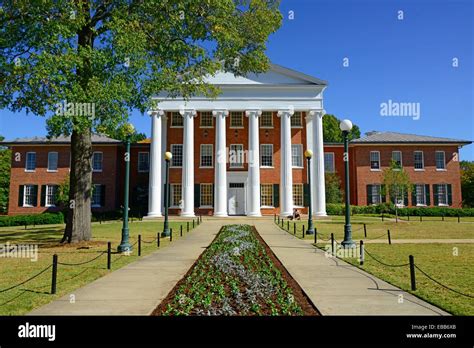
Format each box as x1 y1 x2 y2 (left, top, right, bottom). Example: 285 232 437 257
252 220 449 315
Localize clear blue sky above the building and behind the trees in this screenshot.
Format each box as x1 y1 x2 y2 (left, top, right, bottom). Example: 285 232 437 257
0 0 474 160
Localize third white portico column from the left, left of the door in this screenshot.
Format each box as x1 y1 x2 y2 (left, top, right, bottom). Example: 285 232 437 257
212 110 229 216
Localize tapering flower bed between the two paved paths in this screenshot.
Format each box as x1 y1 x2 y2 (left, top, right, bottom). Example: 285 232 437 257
153 225 318 315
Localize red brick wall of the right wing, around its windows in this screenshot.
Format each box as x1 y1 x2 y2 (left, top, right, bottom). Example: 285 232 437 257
353 145 462 207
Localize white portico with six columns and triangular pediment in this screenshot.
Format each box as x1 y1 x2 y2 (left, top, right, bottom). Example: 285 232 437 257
148 65 327 217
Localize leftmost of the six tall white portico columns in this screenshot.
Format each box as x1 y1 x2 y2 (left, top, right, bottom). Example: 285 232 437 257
147 110 164 217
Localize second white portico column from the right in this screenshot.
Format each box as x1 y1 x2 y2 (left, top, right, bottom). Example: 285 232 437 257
278 108 294 216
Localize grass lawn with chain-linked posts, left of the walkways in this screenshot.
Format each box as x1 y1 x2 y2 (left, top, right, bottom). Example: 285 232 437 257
0 221 198 315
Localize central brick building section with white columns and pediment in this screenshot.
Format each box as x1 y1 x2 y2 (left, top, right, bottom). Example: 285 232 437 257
148 64 327 217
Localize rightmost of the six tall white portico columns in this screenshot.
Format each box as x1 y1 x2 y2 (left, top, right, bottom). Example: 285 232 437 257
309 109 327 216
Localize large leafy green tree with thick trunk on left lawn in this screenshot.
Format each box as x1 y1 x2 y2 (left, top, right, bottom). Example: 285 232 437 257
0 0 282 242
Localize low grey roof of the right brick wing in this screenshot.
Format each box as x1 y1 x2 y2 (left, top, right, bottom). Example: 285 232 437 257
351 131 472 145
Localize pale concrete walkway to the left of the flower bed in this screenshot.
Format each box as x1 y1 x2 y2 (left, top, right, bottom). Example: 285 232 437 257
29 220 222 315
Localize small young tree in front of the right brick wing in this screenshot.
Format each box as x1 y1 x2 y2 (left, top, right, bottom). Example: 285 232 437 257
382 160 413 216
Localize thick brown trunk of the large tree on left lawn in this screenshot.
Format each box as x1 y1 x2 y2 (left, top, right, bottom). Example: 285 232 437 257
62 130 92 243
